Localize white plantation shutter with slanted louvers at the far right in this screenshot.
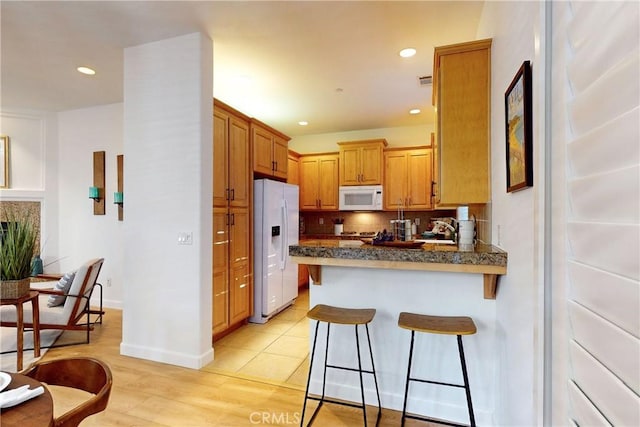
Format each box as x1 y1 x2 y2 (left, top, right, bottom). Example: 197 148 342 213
564 1 640 426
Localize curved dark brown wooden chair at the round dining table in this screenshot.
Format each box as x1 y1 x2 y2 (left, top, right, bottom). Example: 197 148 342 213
22 357 113 427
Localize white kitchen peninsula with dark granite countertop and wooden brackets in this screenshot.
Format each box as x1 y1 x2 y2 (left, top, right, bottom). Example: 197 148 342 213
289 240 507 425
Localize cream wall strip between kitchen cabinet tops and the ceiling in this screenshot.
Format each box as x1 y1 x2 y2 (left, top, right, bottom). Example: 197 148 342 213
289 125 433 154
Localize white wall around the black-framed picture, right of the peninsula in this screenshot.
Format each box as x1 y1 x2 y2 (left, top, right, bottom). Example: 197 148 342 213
478 2 544 426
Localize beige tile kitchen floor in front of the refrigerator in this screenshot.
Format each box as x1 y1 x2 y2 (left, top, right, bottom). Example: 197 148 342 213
203 289 309 390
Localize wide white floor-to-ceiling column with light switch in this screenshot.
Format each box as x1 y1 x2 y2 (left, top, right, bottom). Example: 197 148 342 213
120 33 213 369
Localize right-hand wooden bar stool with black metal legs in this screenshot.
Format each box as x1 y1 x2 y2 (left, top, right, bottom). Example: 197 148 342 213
398 312 476 426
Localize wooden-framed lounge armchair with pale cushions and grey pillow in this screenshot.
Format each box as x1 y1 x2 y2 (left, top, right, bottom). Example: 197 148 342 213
0 258 104 344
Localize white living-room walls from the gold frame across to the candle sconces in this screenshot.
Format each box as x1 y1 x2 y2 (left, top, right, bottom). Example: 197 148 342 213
0 104 123 308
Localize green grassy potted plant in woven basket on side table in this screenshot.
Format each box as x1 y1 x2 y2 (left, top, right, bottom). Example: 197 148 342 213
0 214 38 299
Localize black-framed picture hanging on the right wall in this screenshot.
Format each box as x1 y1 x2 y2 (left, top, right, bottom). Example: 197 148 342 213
504 61 533 193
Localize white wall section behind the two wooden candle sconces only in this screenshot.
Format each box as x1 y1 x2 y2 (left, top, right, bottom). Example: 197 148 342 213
58 104 127 308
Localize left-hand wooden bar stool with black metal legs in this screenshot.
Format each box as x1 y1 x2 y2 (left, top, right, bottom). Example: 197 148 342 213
300 304 381 426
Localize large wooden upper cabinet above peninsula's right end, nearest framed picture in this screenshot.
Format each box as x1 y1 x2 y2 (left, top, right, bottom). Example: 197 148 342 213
433 39 491 206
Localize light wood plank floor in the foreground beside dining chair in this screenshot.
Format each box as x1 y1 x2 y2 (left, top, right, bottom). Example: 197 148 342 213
43 302 428 427
